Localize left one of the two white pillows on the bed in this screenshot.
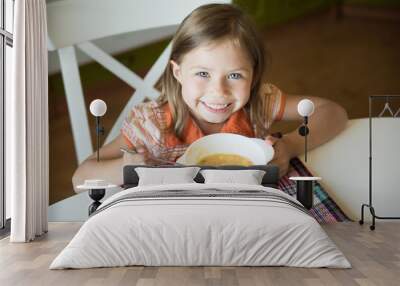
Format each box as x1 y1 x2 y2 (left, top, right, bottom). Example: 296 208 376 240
135 167 200 186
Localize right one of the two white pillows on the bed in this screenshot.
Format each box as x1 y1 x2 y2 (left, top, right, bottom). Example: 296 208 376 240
200 169 265 185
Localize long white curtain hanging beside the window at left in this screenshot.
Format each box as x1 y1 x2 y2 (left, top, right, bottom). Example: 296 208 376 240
6 0 49 242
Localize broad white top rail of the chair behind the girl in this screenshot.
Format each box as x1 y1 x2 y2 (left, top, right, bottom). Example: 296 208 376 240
47 0 230 50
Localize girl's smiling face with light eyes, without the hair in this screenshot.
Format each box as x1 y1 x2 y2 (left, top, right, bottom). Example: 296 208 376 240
171 40 253 123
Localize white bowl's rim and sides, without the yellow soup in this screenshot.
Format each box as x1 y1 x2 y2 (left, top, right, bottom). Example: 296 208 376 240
177 133 274 165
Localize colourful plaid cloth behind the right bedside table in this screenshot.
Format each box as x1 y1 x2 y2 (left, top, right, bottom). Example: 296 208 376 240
278 158 351 223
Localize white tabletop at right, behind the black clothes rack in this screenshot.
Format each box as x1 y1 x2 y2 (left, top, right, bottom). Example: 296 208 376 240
307 118 400 220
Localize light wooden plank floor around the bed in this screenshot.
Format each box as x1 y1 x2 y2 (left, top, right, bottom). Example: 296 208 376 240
0 221 400 286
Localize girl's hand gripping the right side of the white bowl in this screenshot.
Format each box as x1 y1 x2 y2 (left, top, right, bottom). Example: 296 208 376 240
265 135 291 178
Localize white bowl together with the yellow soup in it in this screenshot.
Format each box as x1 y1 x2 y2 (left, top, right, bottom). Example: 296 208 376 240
177 133 274 166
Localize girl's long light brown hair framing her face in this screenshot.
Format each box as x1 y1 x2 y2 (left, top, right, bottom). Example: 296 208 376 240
158 4 269 139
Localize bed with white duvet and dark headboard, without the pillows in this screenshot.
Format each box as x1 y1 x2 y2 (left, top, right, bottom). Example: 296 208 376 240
50 166 351 269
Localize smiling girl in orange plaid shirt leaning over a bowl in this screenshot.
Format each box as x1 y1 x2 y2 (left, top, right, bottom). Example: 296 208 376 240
73 4 347 190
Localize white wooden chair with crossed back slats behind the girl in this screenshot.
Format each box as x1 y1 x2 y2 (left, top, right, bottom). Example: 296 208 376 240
47 0 230 163
